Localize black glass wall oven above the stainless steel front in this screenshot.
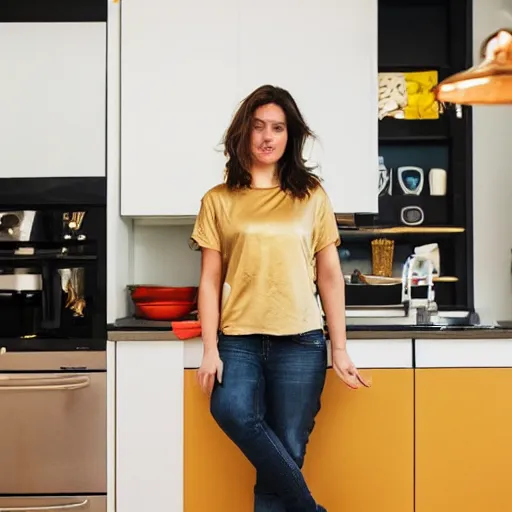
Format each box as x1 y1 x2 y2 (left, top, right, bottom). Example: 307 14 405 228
0 178 106 351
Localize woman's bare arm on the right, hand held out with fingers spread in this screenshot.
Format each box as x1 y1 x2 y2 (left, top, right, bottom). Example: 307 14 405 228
316 244 369 388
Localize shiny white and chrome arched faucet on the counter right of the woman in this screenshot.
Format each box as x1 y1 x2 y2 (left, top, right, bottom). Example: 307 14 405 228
402 254 437 325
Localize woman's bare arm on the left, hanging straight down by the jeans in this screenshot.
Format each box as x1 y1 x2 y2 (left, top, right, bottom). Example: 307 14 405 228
197 248 223 395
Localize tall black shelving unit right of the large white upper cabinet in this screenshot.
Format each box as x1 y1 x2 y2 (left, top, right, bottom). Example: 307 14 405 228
374 0 474 309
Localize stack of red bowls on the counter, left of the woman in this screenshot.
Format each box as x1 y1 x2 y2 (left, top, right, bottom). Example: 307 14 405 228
130 286 198 321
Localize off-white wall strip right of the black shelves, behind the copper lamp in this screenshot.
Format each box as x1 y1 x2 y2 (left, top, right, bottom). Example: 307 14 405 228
473 0 512 320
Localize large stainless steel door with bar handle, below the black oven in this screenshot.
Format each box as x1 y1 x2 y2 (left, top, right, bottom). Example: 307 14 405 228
0 362 107 494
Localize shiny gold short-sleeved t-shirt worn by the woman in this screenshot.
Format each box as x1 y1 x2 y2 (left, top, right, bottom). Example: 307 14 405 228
192 184 340 335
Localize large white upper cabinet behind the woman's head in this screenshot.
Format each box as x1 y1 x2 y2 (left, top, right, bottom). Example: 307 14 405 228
121 0 378 217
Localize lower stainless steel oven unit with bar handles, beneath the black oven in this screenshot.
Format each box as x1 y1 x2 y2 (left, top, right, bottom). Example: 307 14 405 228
0 340 107 512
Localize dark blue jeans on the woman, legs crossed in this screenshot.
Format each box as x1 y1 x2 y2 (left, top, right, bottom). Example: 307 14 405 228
210 330 327 512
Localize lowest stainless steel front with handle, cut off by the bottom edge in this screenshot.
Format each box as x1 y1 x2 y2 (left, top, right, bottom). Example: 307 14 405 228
0 496 107 512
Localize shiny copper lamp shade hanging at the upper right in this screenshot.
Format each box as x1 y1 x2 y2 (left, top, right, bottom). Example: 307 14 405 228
434 29 512 105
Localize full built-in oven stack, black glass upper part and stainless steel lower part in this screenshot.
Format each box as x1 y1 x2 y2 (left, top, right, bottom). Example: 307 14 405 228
0 178 107 512
